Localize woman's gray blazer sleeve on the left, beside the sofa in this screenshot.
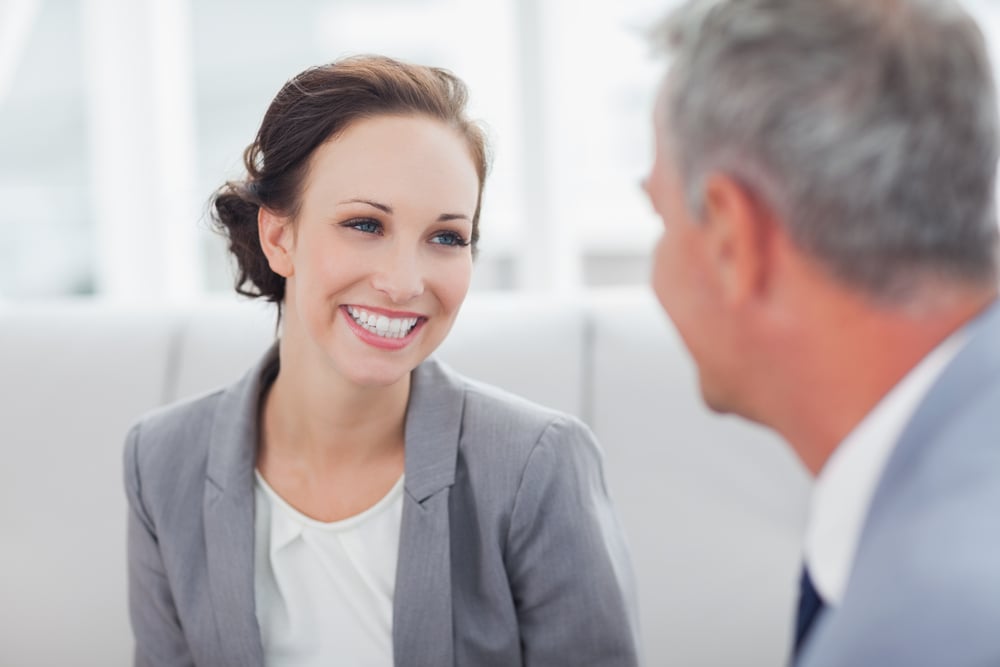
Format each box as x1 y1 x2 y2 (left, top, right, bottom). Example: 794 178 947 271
125 424 194 667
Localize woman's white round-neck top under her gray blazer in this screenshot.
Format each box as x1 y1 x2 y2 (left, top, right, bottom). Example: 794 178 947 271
254 472 403 667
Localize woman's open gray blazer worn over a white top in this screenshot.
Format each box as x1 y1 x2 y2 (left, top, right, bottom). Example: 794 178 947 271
125 348 638 667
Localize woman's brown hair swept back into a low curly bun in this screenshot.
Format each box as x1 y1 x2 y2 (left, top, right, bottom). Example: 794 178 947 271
211 56 489 304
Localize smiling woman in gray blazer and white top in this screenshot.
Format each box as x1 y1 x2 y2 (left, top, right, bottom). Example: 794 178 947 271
125 57 637 667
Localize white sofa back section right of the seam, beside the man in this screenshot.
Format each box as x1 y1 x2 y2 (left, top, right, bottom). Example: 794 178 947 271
587 289 810 667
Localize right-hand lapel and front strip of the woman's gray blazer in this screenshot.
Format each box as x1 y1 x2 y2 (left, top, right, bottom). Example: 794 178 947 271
392 360 465 667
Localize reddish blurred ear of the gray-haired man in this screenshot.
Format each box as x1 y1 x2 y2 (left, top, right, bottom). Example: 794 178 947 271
704 172 775 304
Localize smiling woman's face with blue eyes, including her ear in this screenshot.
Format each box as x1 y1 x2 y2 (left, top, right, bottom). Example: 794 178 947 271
270 116 480 386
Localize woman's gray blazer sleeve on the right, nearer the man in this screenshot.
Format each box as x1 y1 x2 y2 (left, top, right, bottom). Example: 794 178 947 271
506 417 639 667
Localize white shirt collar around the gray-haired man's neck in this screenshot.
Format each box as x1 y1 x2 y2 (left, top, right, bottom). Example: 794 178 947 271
804 328 968 606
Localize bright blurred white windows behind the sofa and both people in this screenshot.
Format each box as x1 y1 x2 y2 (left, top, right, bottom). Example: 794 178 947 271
0 0 1000 303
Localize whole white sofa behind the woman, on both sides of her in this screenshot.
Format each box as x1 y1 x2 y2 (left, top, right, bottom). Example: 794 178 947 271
0 289 809 667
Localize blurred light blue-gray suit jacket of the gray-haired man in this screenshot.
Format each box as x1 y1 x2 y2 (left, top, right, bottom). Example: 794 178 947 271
799 304 1000 667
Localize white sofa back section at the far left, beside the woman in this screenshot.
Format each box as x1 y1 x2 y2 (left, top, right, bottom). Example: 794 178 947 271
0 301 172 667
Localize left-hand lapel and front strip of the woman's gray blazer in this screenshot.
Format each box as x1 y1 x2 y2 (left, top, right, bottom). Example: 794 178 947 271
203 346 277 667
